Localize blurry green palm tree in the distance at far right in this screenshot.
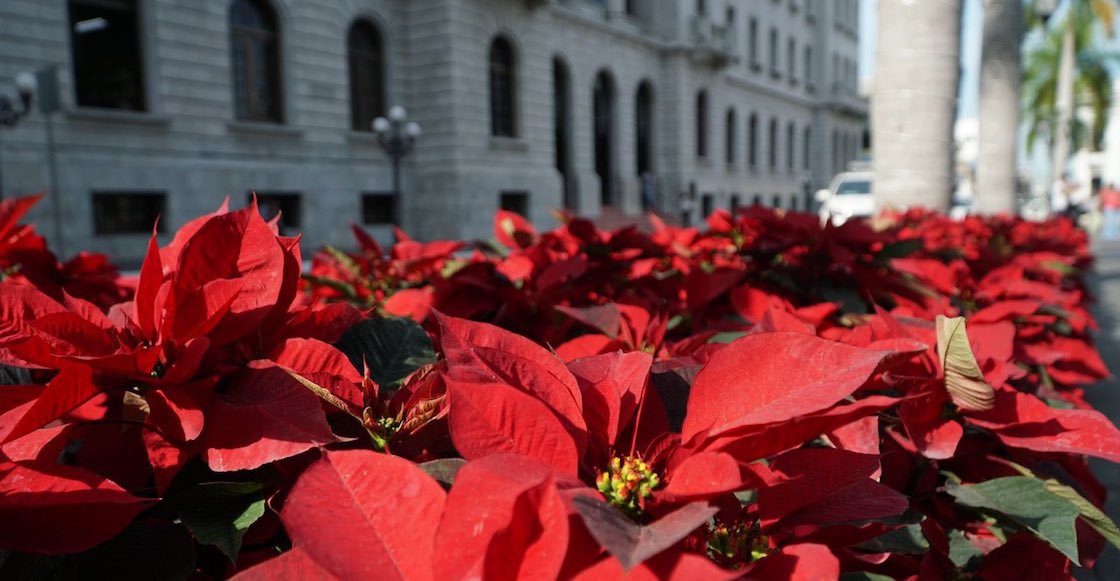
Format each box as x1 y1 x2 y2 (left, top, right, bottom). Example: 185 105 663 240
1023 12 1112 164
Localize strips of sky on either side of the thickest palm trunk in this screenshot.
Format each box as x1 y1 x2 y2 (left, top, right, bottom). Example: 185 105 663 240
859 0 983 119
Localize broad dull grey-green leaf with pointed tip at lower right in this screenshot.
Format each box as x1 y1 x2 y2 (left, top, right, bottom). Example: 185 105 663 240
945 476 1081 564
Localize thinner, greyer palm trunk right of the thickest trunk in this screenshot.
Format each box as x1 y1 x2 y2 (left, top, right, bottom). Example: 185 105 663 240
977 0 1024 214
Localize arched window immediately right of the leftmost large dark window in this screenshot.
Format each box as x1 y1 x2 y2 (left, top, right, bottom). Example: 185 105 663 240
230 0 283 122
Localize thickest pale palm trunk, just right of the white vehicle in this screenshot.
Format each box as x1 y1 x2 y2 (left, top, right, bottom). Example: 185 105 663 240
871 0 962 212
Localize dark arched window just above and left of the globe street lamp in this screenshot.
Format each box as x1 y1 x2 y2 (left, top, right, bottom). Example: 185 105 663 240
346 20 385 131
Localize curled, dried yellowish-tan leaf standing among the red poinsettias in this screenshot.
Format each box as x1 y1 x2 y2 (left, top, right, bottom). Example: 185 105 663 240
937 315 996 412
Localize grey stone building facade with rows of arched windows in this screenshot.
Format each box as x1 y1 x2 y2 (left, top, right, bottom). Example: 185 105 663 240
0 0 867 263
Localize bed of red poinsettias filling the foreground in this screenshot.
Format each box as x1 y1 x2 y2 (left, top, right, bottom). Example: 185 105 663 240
0 197 1120 580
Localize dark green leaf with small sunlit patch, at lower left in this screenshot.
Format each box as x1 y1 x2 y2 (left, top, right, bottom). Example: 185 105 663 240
171 482 264 563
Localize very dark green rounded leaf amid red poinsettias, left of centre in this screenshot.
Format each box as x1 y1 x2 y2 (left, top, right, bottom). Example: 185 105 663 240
335 317 436 387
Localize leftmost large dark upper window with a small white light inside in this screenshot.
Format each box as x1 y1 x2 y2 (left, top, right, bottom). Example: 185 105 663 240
68 0 147 111
